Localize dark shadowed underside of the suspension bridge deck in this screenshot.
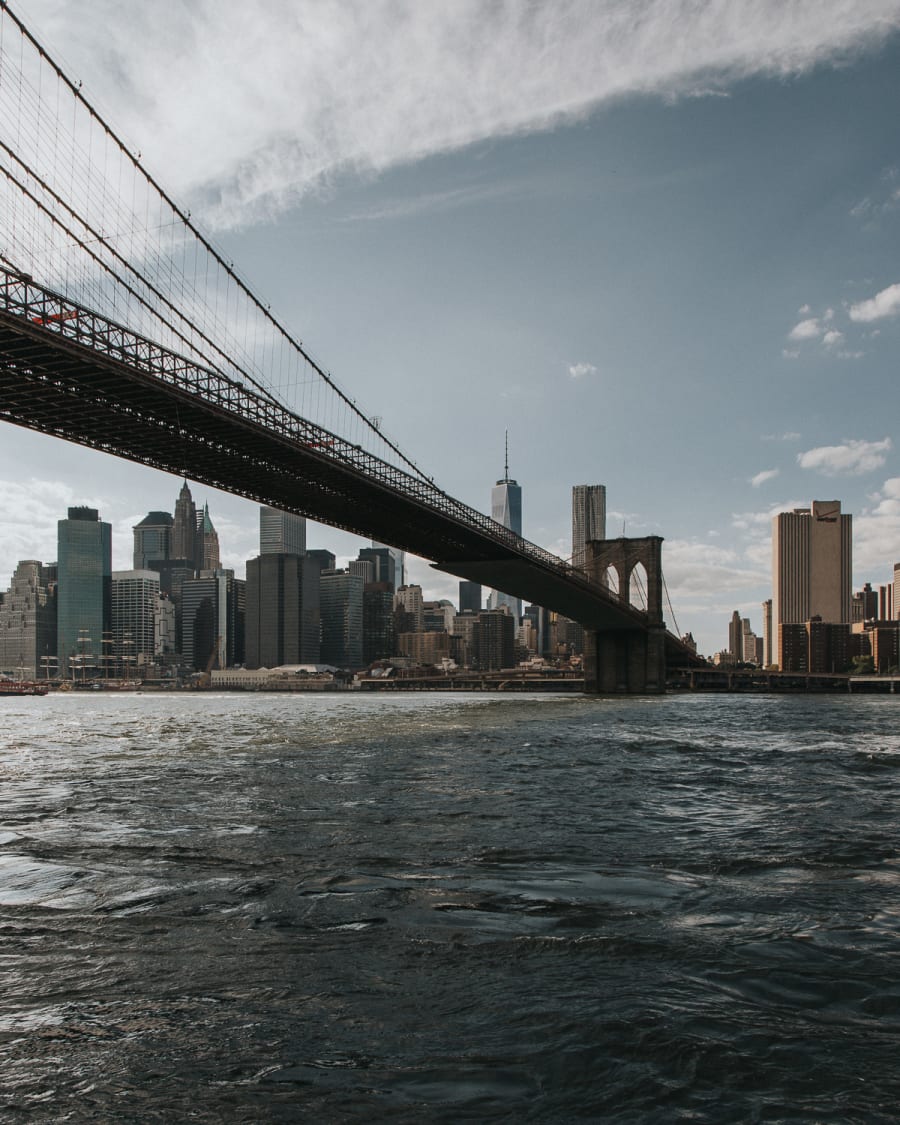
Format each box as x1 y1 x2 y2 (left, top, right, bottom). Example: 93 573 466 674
0 311 702 663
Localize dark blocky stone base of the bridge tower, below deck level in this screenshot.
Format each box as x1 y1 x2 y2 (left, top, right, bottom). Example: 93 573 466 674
584 628 666 695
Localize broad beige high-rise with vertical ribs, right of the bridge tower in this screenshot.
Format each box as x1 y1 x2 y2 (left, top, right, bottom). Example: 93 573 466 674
772 500 853 667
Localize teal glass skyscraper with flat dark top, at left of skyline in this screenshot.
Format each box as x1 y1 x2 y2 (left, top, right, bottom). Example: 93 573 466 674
57 507 113 678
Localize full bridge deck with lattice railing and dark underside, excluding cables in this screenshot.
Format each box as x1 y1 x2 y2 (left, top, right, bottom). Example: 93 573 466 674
0 269 692 664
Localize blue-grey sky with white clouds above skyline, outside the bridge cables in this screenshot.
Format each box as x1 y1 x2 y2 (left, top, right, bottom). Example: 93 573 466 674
0 0 900 654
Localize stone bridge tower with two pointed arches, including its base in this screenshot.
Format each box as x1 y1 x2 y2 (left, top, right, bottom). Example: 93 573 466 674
584 536 666 695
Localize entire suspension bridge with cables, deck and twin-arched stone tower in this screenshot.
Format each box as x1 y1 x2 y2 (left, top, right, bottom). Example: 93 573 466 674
0 5 696 693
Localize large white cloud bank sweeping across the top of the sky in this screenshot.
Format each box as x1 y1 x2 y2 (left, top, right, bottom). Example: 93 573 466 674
28 0 900 226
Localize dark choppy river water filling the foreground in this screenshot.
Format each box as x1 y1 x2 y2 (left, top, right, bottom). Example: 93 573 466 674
0 694 900 1122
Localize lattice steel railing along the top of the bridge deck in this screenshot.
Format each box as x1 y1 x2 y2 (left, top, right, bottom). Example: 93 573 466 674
0 267 641 614
